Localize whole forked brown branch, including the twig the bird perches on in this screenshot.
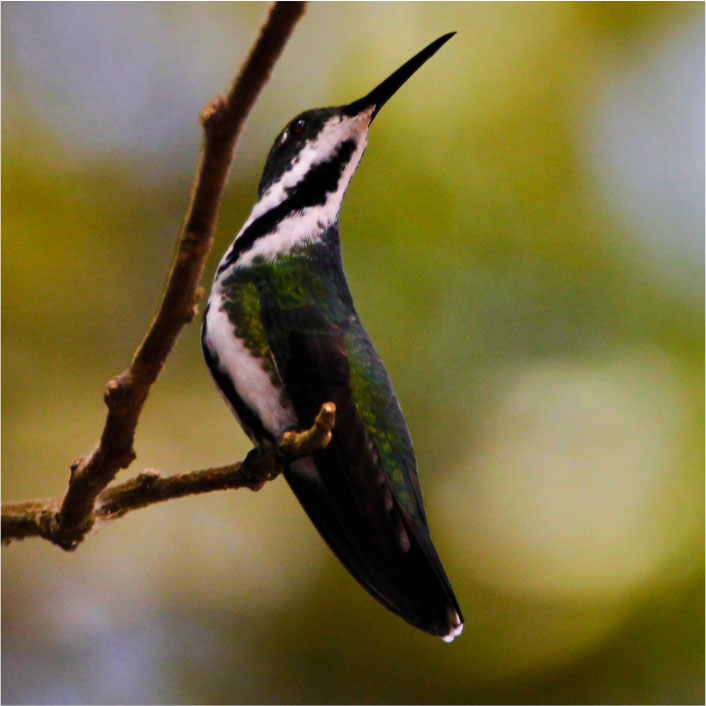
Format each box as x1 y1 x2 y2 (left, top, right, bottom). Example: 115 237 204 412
2 2 308 550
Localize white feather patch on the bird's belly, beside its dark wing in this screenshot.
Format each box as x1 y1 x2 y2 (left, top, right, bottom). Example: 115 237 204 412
206 292 296 434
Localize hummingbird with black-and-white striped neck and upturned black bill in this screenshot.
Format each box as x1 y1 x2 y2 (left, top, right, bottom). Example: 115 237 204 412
201 32 463 642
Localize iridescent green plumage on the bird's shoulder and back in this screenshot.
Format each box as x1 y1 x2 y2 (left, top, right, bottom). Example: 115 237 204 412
223 245 424 516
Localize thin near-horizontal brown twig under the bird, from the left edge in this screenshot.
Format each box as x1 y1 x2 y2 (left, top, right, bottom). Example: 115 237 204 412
2 402 336 544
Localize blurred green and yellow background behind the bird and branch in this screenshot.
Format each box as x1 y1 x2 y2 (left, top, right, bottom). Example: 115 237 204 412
2 3 704 703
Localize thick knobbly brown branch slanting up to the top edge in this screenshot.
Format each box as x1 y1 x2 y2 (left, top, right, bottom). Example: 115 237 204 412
2 2 306 549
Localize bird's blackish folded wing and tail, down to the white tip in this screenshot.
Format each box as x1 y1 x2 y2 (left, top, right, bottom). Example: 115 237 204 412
261 292 462 637
